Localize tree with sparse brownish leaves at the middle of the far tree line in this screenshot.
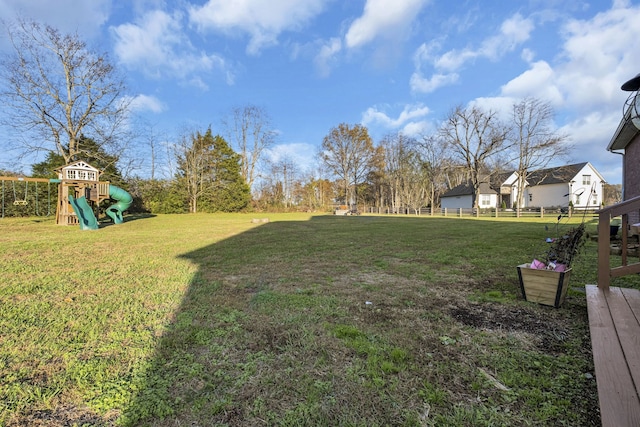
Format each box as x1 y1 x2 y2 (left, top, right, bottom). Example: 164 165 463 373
320 123 376 208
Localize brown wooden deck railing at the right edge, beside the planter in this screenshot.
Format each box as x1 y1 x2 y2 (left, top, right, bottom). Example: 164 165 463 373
597 196 640 290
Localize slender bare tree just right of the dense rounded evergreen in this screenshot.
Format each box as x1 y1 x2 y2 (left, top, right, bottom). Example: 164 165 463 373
223 105 276 188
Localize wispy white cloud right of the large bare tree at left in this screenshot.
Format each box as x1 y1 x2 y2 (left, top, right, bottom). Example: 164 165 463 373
112 10 233 89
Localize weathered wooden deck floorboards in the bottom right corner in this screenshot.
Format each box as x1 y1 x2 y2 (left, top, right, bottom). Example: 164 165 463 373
586 285 640 427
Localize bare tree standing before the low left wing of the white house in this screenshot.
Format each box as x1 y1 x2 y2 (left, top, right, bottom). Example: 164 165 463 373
440 106 509 208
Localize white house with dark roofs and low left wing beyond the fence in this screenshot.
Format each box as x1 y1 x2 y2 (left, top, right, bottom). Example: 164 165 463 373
440 162 605 209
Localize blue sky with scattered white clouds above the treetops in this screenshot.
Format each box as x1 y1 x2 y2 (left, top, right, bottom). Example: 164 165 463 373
0 0 640 183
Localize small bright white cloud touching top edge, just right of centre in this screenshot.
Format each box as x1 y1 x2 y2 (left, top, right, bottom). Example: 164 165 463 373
345 0 428 48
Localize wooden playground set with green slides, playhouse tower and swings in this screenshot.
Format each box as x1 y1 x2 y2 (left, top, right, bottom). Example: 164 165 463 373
0 161 133 230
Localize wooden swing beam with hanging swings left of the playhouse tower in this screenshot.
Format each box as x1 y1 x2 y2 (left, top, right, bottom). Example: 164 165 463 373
0 176 60 218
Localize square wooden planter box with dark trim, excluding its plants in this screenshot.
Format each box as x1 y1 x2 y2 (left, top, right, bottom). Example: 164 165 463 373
518 264 571 308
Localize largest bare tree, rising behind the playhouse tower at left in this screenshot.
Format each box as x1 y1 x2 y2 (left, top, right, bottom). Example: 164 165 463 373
0 21 130 163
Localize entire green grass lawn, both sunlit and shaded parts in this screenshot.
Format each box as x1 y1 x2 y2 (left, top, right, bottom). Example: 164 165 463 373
0 214 633 426
